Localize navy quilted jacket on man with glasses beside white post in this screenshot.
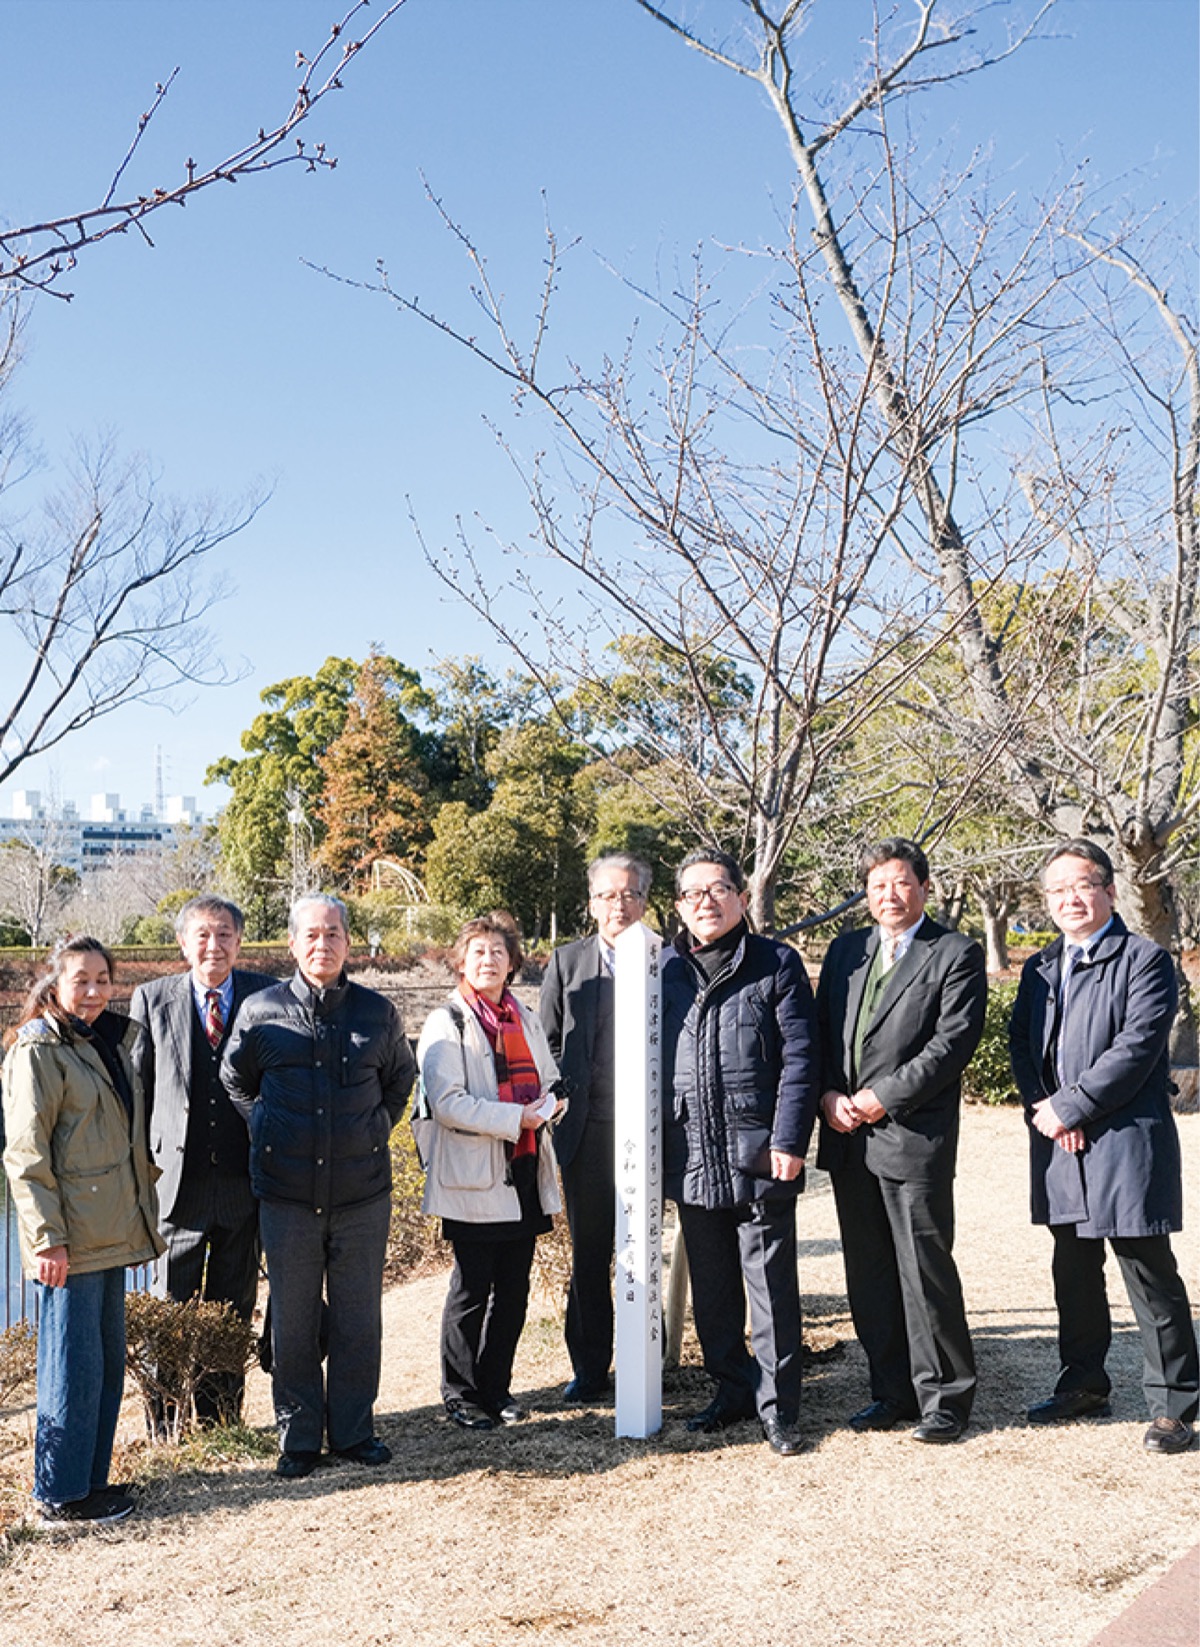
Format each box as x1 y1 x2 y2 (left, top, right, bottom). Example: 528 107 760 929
662 932 818 1207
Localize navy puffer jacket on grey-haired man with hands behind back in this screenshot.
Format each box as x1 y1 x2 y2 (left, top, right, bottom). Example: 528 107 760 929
221 973 416 1212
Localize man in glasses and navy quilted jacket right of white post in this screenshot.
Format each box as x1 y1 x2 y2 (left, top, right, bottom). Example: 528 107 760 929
663 850 816 1456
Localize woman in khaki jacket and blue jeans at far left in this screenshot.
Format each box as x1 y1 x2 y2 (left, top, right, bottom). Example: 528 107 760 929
3 937 163 1525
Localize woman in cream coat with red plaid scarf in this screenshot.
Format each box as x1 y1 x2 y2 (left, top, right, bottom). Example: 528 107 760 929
416 911 563 1430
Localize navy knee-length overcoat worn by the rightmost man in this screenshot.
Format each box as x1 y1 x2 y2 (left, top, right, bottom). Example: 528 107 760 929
1011 916 1184 1239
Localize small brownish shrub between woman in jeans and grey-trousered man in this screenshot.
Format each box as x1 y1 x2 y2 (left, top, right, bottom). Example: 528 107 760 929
125 1293 255 1441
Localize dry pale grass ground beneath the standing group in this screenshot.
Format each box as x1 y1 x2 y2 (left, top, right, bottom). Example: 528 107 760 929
0 1110 1200 1647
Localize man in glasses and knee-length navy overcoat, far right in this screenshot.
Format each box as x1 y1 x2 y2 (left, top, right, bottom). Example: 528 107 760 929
1011 840 1200 1453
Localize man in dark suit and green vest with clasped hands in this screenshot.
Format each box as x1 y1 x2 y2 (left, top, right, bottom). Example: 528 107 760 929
816 837 988 1441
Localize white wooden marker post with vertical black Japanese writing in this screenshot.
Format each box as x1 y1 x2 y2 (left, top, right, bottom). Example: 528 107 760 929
614 921 662 1436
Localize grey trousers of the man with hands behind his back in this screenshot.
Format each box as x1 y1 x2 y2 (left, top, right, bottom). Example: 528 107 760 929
258 1196 392 1453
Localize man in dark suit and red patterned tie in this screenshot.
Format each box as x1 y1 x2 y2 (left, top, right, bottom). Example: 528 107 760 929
130 896 277 1423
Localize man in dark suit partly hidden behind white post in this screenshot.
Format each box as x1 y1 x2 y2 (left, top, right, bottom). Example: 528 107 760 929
540 853 652 1402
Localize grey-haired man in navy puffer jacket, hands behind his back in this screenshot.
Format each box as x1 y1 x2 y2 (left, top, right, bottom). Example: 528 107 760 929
221 896 415 1479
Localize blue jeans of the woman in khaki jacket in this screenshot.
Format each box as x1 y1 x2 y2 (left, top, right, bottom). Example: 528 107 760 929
33 1267 125 1505
